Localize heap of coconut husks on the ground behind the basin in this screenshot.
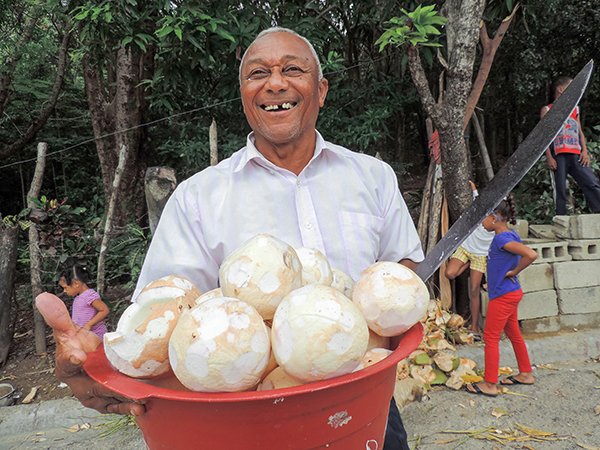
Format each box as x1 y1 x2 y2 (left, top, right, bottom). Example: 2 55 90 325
394 300 482 406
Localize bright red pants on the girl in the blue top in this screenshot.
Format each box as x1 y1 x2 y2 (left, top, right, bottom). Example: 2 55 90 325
483 289 531 384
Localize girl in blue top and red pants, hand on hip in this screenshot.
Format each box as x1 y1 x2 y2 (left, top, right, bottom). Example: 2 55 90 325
466 195 537 397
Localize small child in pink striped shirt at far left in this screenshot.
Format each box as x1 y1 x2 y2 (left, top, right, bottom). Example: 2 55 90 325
58 265 110 339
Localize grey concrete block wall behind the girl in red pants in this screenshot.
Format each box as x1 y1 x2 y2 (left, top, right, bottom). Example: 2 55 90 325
482 214 600 333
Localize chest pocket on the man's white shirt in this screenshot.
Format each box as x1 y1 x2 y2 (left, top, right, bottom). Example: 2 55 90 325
338 211 383 279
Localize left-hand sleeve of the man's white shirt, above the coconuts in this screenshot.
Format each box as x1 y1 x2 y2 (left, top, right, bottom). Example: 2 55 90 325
132 182 219 301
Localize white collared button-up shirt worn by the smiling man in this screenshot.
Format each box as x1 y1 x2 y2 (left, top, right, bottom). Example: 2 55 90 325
133 132 423 299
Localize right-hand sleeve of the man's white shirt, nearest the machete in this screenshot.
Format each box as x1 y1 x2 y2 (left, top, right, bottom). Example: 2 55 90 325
378 164 425 262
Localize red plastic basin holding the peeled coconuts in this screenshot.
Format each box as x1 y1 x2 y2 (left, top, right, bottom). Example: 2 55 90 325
84 323 423 450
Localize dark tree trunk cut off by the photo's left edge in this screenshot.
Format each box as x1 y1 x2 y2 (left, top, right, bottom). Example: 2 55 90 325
0 225 19 367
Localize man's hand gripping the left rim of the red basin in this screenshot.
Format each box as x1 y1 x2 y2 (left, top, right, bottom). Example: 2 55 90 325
35 292 145 416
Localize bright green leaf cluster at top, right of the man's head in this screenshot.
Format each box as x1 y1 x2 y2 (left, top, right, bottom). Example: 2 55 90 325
375 5 448 51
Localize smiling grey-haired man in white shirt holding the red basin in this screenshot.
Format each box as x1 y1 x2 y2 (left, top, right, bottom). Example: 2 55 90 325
40 28 423 450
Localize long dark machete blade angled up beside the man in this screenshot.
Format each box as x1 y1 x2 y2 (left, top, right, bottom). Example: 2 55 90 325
415 60 594 281
